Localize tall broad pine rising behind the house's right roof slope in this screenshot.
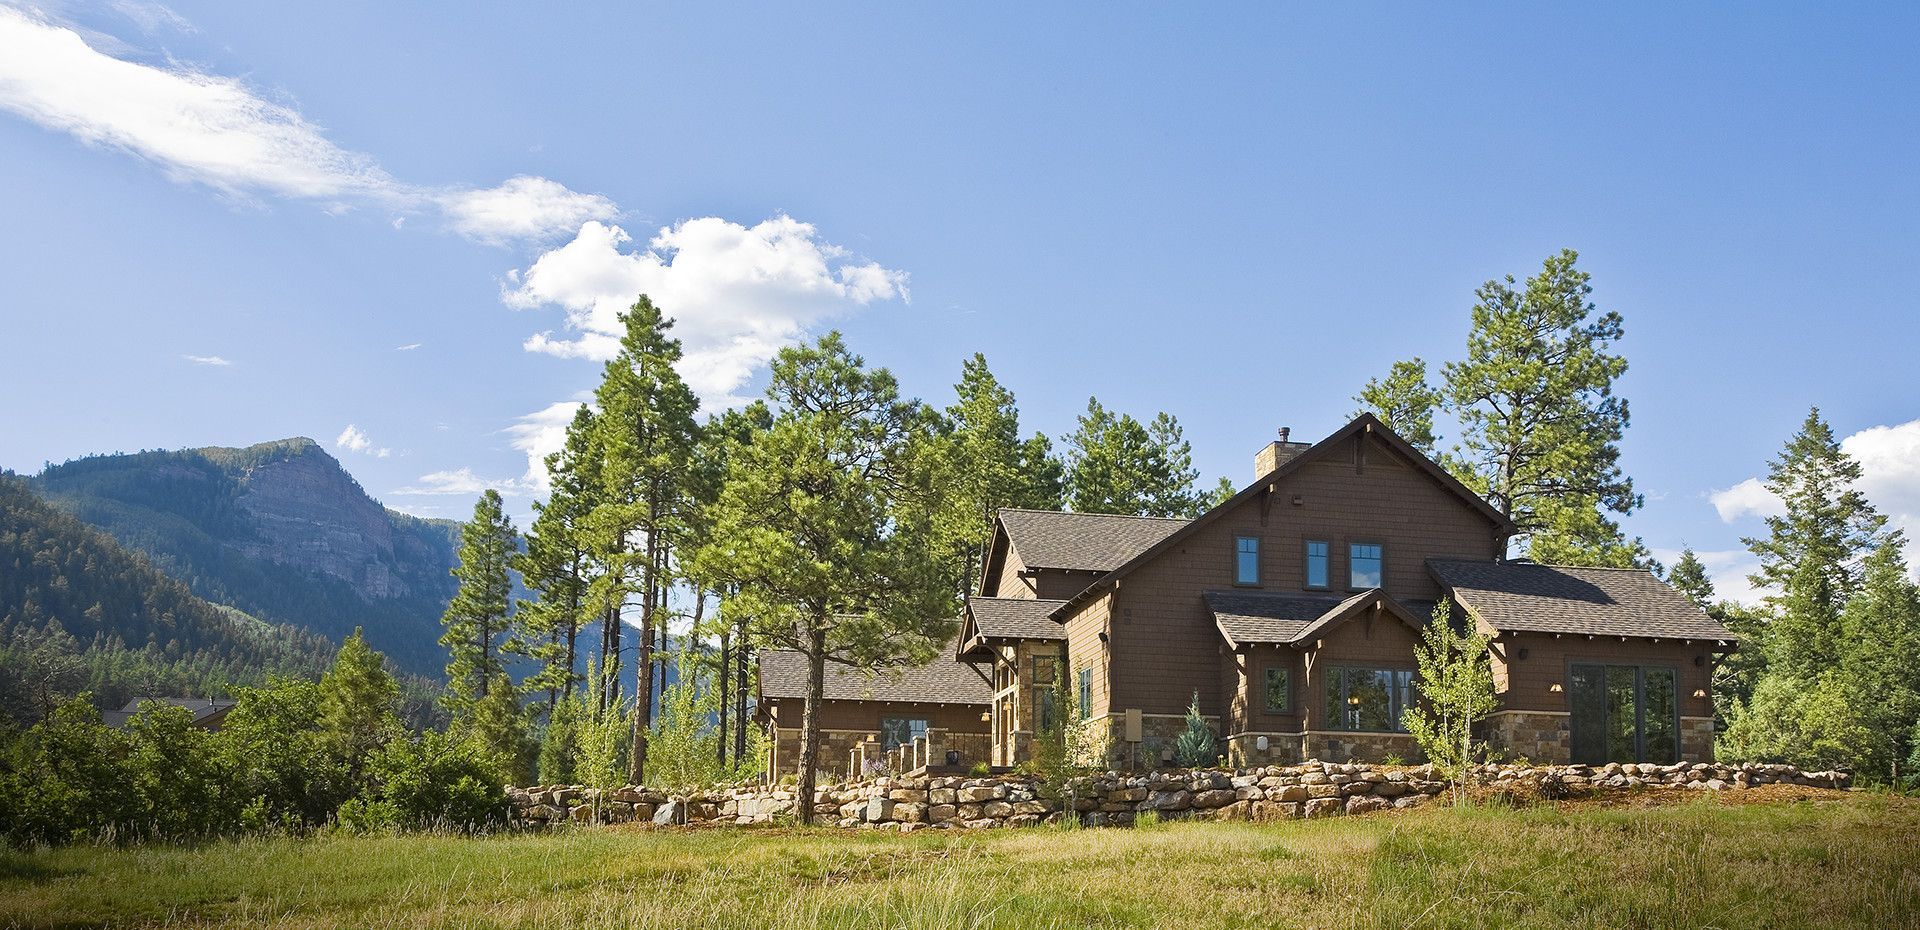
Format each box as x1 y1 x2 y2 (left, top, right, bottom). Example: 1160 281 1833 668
1442 250 1653 567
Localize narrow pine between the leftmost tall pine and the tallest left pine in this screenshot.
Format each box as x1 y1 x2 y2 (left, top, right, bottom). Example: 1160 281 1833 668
507 404 601 721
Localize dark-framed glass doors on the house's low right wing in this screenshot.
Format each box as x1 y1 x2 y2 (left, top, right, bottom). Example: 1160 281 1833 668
1569 665 1680 765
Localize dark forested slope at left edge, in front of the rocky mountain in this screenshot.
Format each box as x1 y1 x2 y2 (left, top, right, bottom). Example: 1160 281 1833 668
0 473 334 721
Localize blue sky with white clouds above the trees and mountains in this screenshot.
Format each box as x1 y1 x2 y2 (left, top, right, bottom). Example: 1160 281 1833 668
0 0 1920 599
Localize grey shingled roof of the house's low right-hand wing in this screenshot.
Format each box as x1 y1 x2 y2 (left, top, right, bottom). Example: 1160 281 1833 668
1427 559 1734 640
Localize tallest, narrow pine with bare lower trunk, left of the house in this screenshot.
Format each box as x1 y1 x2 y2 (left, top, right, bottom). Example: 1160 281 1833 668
591 294 701 784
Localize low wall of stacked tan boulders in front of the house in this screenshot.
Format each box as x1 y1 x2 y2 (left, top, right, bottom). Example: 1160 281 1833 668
507 761 1851 830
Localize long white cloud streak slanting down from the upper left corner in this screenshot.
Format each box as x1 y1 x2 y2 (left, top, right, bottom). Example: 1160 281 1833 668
0 4 616 242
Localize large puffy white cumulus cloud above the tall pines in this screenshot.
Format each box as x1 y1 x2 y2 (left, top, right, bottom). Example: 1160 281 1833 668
505 215 908 405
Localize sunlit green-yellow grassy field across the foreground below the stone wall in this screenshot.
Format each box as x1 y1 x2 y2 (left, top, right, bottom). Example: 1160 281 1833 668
0 794 1920 928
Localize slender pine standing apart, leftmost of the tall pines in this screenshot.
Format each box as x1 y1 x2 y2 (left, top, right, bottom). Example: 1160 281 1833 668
440 488 516 717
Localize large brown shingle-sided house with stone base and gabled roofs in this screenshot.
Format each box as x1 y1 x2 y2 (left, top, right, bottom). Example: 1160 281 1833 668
760 415 1732 772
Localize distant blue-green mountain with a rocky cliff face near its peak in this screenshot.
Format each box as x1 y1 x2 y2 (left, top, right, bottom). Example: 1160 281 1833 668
33 438 459 676
